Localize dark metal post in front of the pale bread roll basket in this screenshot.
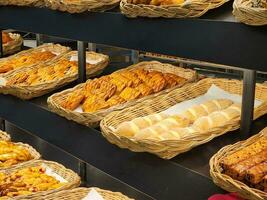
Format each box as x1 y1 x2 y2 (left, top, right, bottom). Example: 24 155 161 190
240 70 256 137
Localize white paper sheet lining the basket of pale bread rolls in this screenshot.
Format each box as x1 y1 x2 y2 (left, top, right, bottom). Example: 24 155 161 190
162 84 262 115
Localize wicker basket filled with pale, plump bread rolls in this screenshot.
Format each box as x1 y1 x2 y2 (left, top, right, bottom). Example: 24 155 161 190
100 78 267 159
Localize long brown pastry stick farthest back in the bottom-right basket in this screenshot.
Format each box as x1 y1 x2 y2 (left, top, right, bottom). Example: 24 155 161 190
220 137 267 171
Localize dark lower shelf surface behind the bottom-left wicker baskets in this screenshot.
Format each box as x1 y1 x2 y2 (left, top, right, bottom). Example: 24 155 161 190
6 122 153 200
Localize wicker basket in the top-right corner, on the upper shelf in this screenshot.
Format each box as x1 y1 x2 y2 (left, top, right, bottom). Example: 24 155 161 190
233 0 267 26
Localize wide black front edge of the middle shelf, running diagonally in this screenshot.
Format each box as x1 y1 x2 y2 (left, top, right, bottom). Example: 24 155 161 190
0 95 223 200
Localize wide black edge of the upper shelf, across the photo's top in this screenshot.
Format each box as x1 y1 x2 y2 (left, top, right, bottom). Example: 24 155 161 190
0 5 267 71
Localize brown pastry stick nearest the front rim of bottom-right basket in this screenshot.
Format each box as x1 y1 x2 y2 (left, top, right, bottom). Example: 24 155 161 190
246 160 267 184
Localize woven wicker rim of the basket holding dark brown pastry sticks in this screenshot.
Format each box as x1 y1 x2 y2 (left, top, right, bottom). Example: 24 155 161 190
210 127 267 200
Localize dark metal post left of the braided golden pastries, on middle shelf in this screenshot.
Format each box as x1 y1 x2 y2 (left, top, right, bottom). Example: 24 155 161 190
77 41 86 83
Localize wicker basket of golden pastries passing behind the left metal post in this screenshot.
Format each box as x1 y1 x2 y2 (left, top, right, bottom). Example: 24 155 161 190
0 51 109 99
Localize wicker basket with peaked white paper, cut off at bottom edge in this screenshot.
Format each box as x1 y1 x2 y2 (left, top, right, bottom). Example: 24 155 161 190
35 187 133 200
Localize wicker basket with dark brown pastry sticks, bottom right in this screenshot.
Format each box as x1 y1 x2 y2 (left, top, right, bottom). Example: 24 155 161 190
210 128 267 200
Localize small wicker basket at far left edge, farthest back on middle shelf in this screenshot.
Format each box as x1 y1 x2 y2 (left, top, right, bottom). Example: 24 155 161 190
3 33 23 55
